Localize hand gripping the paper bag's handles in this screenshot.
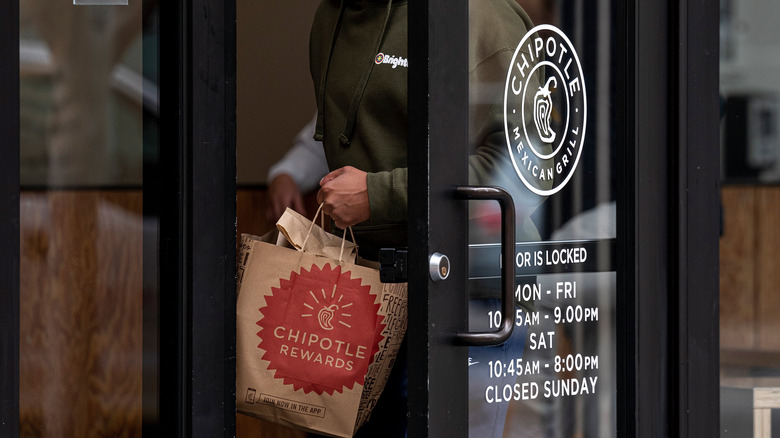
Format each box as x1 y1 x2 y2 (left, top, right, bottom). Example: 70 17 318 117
317 166 370 229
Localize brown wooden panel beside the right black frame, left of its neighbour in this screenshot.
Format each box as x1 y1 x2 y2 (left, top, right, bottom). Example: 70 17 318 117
720 186 757 350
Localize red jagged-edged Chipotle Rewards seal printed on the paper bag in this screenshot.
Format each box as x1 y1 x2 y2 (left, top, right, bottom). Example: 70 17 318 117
257 264 384 395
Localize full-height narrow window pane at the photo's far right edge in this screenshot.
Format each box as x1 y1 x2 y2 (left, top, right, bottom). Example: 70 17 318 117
720 0 780 437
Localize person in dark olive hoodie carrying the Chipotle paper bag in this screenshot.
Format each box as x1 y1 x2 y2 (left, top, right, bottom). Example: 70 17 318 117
310 0 544 437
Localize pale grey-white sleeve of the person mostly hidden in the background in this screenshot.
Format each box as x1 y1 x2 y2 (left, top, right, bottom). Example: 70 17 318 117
268 114 328 192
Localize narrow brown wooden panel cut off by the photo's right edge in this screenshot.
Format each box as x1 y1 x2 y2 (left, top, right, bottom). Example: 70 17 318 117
754 187 780 351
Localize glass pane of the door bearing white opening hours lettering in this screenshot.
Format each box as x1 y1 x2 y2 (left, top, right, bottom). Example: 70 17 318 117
468 0 622 437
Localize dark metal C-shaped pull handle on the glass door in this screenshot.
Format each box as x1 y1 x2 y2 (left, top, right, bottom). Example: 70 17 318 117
455 186 515 346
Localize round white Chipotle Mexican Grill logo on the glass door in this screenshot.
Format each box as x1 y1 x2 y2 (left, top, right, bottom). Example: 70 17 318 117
504 24 588 196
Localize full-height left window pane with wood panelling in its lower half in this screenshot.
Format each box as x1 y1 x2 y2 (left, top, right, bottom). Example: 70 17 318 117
19 0 157 437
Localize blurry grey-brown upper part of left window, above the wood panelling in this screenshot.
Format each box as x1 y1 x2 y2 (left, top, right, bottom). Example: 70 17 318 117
20 0 143 187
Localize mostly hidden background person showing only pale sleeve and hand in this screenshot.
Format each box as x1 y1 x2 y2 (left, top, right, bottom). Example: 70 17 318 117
265 115 328 224
